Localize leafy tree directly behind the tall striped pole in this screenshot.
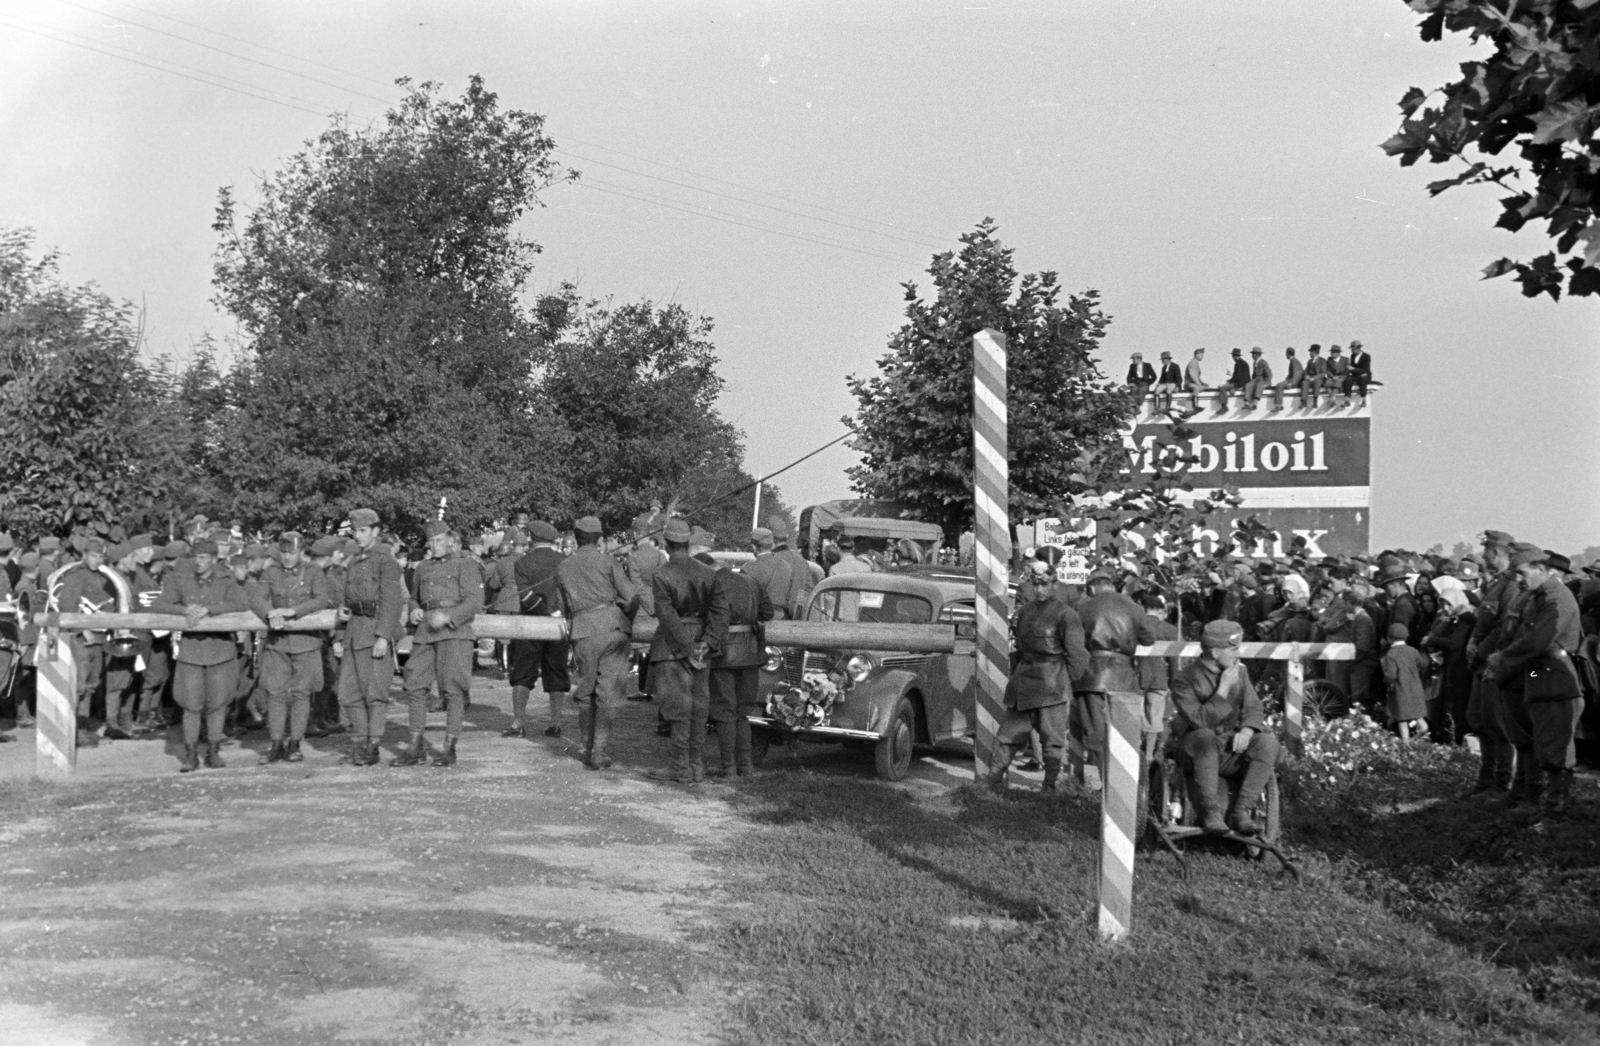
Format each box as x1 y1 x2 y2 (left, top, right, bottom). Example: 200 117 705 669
845 219 1133 542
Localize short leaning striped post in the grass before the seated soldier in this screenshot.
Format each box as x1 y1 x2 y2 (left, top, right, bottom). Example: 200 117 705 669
1099 693 1144 944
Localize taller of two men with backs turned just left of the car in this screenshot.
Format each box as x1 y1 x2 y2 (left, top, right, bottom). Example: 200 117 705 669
648 520 728 784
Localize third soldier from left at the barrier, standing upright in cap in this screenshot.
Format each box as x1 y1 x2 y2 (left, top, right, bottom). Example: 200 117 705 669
332 509 405 766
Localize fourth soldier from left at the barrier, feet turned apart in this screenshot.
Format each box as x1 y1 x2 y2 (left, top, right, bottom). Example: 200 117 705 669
387 520 483 766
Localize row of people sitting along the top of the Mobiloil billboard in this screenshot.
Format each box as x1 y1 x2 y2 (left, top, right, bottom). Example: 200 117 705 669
1126 341 1374 414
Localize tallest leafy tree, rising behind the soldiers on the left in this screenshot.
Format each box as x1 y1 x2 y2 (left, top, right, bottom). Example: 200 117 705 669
211 77 571 529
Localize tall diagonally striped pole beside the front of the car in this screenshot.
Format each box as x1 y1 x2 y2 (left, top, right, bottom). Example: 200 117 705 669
973 328 1011 781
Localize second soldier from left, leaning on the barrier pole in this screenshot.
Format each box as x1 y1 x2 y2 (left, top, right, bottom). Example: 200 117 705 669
250 531 333 765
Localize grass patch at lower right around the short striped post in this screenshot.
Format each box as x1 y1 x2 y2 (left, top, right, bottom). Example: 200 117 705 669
714 773 1600 1046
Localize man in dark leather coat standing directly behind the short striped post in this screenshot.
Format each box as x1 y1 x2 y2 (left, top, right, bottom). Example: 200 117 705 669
1072 569 1155 786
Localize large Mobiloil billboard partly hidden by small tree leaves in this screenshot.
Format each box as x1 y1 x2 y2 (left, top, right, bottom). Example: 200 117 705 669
1125 397 1373 555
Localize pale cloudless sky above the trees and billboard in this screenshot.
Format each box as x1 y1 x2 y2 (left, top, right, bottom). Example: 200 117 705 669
0 0 1600 552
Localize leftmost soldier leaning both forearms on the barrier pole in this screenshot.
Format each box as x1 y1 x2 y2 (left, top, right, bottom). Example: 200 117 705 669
150 537 250 774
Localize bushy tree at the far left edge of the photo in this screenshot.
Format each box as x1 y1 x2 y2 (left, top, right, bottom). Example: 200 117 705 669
0 229 184 536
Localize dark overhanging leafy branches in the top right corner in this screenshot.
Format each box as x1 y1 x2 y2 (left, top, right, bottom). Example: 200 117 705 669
1382 0 1600 299
